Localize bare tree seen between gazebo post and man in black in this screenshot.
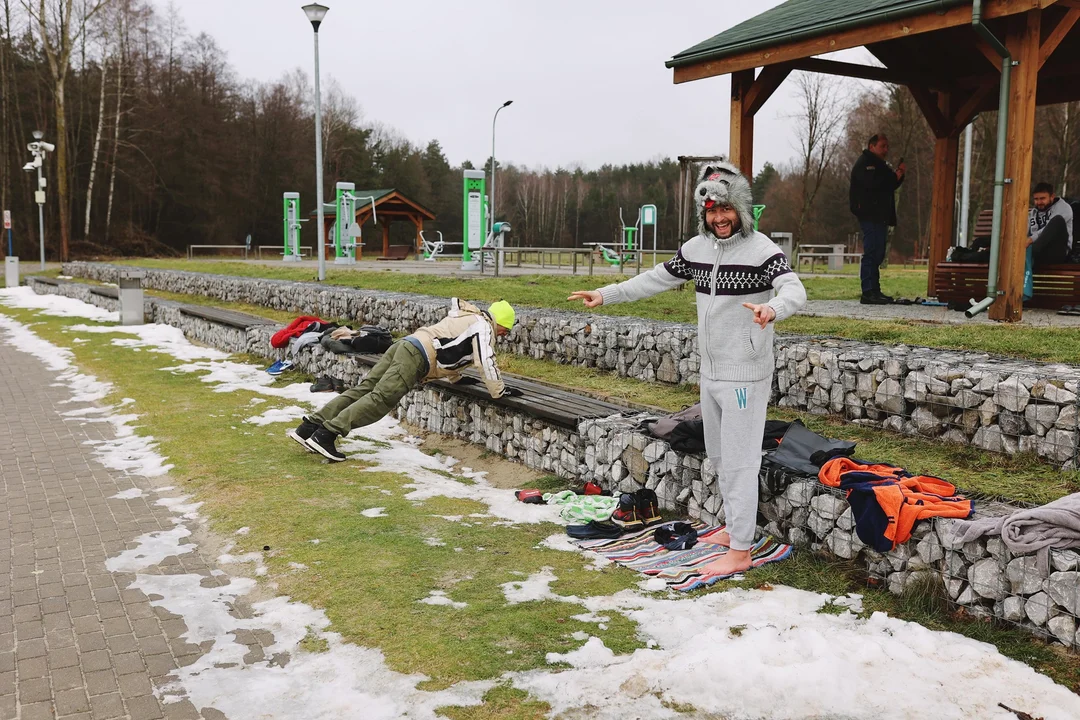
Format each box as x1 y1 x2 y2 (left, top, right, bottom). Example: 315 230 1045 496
795 72 848 245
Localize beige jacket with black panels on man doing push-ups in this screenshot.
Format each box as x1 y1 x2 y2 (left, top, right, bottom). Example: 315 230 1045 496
411 298 507 397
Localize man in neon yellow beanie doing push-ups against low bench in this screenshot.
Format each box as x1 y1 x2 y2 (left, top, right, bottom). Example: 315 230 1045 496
288 298 522 462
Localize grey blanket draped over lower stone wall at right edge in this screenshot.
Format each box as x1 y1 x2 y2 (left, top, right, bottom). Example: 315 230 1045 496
954 492 1080 568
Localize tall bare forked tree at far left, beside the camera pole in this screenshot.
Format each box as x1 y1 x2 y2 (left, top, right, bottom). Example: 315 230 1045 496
23 0 110 262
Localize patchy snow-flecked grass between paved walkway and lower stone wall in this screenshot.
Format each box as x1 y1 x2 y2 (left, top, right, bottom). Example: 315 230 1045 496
6 308 1080 699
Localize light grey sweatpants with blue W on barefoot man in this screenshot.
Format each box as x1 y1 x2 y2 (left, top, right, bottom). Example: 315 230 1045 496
701 375 772 551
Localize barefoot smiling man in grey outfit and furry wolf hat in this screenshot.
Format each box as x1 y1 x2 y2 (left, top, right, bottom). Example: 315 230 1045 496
568 162 807 575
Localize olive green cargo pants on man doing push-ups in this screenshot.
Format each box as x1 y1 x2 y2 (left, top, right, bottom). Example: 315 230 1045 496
310 340 427 437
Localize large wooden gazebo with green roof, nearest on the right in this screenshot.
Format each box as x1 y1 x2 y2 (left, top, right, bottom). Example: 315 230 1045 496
666 0 1080 321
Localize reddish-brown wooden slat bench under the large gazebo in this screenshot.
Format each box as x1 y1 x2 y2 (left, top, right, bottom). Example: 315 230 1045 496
934 209 1080 310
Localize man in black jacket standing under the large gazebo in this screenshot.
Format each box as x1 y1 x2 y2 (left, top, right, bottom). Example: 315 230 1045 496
849 134 907 305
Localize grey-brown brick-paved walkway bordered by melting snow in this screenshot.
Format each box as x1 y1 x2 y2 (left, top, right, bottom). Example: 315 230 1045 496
0 341 224 720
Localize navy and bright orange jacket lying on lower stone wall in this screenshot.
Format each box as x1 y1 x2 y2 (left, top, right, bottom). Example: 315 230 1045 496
818 458 975 553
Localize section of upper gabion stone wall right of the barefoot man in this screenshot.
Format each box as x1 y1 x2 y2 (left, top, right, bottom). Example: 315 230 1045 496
773 336 1080 470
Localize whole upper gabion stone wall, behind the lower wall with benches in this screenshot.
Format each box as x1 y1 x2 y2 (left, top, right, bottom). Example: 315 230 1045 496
56 262 1080 470
